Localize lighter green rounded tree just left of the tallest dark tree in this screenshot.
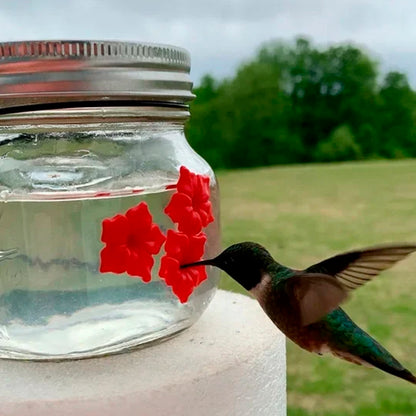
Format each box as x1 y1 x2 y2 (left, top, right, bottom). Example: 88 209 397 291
216 62 301 167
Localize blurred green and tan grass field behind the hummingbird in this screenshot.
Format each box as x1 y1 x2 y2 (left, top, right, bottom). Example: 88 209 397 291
218 161 416 416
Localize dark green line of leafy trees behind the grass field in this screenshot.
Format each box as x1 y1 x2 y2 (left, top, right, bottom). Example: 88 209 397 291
186 38 416 168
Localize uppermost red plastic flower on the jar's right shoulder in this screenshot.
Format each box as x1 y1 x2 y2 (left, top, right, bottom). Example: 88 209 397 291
165 166 214 235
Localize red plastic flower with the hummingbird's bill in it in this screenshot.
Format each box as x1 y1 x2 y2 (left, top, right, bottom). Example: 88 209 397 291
159 230 207 303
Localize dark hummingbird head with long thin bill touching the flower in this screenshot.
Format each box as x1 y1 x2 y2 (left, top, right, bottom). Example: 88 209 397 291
181 242 274 290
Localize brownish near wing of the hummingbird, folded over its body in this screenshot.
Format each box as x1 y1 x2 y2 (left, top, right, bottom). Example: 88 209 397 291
276 272 348 326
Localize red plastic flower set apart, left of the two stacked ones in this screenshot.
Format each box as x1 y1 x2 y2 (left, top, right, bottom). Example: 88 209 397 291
100 202 166 282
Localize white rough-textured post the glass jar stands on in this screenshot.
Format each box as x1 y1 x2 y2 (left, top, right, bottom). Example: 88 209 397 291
0 291 286 416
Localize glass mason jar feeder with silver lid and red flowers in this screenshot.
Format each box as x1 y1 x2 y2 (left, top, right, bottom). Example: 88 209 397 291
0 41 220 360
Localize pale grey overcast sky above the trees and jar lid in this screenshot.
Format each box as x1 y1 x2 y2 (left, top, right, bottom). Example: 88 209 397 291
0 0 416 86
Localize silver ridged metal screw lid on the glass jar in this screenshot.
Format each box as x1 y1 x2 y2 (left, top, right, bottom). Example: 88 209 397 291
0 40 194 112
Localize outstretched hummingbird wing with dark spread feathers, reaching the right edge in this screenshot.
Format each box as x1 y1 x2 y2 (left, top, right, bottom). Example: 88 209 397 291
305 244 416 291
